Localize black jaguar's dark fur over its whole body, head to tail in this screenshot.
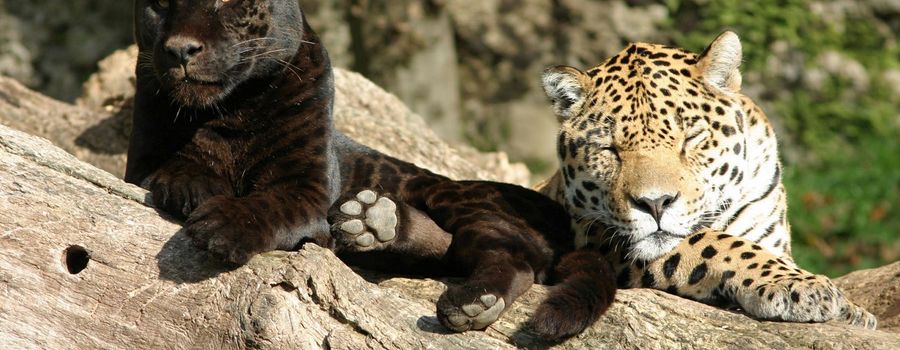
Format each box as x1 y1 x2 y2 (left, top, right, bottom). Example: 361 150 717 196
125 0 615 338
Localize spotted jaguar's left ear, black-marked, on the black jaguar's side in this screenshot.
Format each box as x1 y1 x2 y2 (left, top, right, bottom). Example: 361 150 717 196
541 66 587 121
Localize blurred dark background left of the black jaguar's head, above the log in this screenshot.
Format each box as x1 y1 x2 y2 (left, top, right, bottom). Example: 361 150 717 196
0 0 133 100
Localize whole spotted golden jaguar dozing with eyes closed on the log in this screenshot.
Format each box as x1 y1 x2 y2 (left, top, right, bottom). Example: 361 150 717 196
543 32 876 328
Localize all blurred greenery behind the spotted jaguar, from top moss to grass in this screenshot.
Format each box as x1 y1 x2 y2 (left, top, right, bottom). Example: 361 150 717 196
666 0 900 276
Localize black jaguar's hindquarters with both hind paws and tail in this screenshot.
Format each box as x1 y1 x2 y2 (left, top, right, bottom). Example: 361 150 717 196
329 153 615 338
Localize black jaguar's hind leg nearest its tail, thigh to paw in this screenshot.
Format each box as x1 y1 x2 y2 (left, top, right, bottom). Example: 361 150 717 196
425 182 568 331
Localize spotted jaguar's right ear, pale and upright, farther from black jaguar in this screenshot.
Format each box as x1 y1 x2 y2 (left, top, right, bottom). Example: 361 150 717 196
697 31 743 92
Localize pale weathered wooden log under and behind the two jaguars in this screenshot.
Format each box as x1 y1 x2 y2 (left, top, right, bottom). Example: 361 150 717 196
0 56 900 350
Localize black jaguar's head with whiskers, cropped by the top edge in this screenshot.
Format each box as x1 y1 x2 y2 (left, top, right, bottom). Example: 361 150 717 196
135 0 304 107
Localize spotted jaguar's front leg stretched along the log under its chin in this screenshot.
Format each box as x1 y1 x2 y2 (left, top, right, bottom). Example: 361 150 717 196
632 230 877 329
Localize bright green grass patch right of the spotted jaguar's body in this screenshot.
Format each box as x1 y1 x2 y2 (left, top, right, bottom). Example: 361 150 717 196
784 137 900 276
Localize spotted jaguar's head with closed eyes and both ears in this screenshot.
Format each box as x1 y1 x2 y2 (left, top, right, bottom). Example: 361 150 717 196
543 32 752 260
